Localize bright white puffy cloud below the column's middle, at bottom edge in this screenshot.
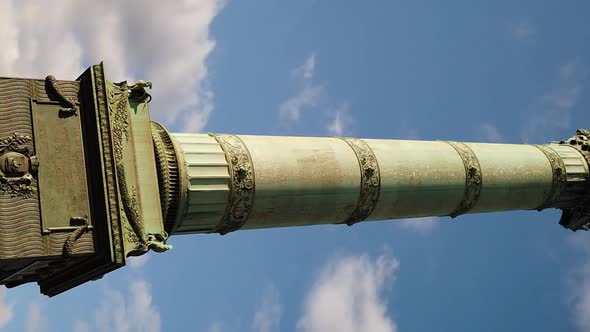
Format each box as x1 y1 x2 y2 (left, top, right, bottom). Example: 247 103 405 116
297 256 399 332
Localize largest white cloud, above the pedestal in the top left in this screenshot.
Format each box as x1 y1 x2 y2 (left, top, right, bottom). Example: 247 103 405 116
0 0 223 131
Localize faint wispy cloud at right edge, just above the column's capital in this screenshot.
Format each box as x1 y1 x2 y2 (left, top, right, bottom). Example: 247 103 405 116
522 60 588 143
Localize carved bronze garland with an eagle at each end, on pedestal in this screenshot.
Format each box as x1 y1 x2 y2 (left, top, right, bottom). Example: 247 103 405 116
108 81 172 255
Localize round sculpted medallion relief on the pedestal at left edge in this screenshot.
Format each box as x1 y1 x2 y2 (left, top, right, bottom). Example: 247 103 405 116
0 132 39 198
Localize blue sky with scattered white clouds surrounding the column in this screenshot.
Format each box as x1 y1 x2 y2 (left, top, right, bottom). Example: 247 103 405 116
0 0 590 332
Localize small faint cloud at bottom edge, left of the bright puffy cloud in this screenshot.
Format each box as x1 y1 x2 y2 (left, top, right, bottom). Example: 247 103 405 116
252 286 283 332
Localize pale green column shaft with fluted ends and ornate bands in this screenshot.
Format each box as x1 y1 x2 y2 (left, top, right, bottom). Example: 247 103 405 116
171 134 588 234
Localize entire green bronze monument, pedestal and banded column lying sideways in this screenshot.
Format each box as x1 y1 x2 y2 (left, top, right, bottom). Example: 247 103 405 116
0 64 590 296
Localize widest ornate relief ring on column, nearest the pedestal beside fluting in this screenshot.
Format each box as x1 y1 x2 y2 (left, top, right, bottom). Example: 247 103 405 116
210 134 254 235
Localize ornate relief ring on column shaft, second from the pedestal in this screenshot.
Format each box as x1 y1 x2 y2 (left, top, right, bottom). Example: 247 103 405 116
341 138 381 226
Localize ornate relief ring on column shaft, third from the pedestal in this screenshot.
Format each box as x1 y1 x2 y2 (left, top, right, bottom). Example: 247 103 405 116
446 141 482 218
